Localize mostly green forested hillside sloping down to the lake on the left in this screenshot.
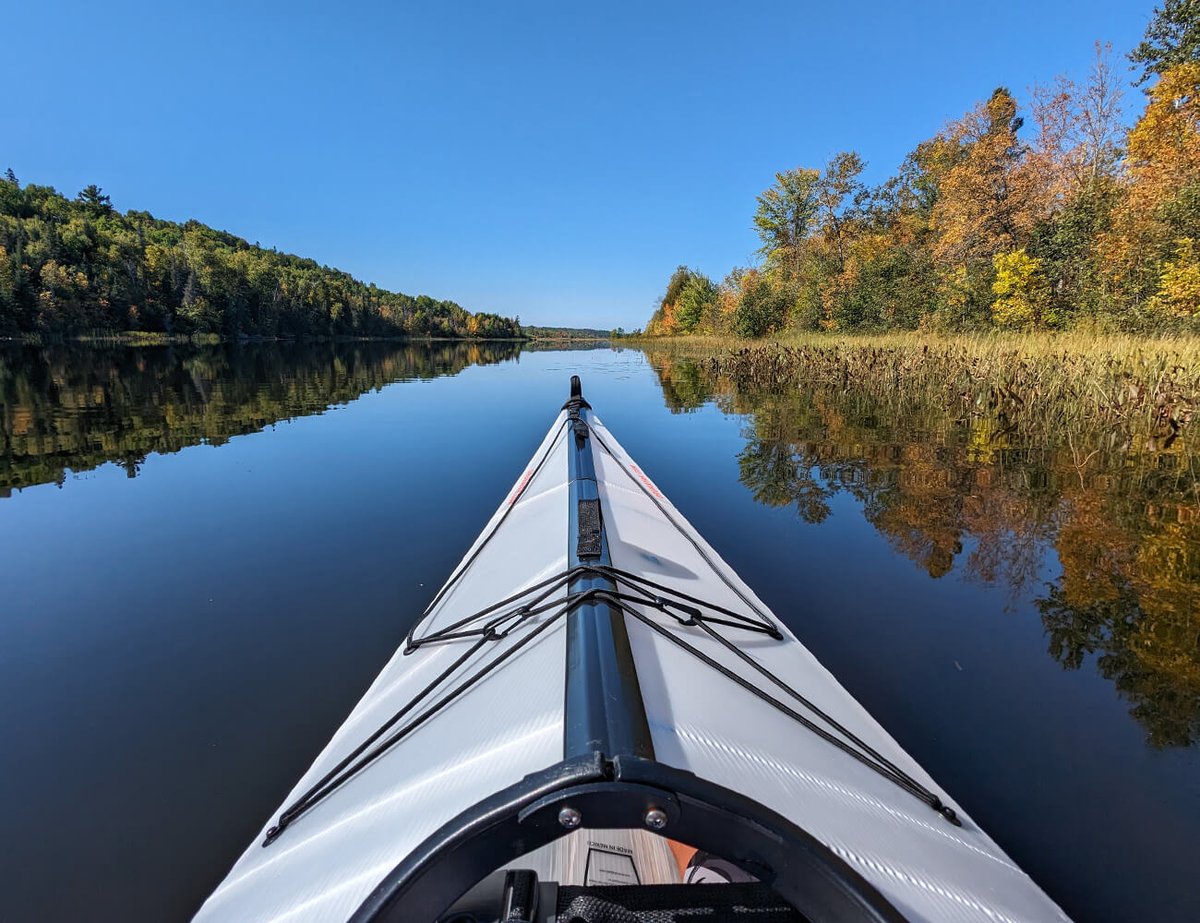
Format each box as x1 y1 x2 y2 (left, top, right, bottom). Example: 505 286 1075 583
0 177 521 340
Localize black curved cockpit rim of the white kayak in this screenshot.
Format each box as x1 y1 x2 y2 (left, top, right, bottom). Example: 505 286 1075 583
350 753 905 923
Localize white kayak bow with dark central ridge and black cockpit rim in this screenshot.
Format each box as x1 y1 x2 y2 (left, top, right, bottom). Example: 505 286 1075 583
196 377 1067 923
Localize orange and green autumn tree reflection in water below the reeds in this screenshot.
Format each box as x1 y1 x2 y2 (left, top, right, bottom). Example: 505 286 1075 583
652 356 1200 747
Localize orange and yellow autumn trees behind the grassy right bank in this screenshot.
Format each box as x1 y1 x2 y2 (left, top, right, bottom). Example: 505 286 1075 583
644 0 1200 337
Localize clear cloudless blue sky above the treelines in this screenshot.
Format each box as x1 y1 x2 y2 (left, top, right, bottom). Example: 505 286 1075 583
0 0 1153 328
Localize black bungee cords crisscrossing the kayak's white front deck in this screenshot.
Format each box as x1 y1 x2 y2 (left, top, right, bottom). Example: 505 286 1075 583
263 556 961 846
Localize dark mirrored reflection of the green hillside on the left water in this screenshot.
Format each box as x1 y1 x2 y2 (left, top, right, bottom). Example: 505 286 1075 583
0 342 518 497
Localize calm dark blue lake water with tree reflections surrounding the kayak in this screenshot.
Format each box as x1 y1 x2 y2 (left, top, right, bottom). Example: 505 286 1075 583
0 343 1200 921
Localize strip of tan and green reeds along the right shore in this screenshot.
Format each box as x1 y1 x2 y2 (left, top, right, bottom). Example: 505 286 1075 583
647 334 1200 449
